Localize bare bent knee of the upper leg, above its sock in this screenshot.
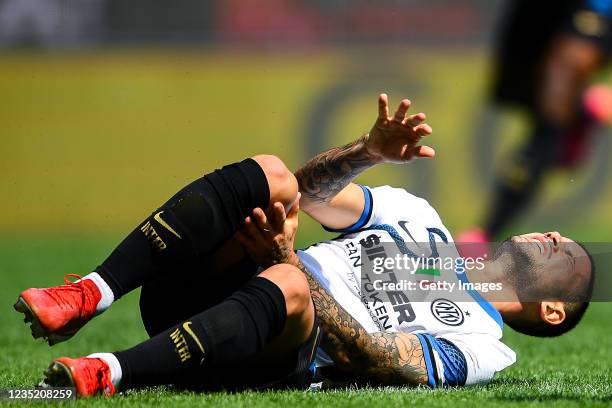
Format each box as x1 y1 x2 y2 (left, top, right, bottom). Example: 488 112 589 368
253 154 298 209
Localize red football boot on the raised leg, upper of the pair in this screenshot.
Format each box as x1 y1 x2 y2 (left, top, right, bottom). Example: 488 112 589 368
13 274 102 346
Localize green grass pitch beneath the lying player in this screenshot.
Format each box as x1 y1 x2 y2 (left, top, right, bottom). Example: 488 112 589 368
0 237 612 407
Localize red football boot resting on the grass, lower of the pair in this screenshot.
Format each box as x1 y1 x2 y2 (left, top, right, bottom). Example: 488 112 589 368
39 357 115 397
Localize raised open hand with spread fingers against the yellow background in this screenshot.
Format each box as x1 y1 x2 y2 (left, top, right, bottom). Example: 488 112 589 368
366 94 436 163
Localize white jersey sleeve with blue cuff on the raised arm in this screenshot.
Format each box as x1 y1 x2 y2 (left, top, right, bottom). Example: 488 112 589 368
323 184 439 234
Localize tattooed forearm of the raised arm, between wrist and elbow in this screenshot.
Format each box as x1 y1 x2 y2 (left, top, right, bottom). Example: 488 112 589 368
295 135 378 203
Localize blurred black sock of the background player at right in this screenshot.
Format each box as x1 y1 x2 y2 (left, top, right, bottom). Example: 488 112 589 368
485 119 564 238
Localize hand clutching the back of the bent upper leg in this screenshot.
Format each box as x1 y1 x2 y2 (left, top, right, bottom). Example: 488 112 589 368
235 193 300 267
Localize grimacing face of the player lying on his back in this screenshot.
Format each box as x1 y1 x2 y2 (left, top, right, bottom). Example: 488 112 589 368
510 232 591 296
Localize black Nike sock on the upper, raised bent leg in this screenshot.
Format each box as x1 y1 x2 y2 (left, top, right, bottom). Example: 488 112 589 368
96 159 270 300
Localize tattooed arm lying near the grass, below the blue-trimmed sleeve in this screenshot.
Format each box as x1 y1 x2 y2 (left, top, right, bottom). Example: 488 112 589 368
297 261 427 385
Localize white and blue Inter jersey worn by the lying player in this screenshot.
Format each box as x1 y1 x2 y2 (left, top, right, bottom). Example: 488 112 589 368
298 186 516 387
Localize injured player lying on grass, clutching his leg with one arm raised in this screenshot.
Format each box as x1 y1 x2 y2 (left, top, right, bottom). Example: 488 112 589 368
15 94 593 396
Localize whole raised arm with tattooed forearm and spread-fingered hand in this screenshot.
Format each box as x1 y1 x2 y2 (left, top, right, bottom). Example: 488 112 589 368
295 94 435 229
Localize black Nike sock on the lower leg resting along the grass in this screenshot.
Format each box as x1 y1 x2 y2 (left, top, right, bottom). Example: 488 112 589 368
115 277 287 389
